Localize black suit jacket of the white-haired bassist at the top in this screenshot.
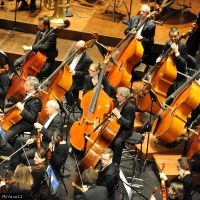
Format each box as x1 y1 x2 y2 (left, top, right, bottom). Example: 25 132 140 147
124 16 156 55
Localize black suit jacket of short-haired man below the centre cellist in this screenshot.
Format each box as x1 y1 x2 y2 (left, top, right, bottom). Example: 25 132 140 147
97 163 119 193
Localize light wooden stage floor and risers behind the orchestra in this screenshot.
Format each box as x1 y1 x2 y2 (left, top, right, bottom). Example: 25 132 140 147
0 0 200 60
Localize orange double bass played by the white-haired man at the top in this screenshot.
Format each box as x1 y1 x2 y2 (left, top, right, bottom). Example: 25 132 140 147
105 11 157 87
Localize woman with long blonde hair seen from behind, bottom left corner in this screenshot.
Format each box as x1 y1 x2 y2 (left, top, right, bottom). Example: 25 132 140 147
1 164 33 200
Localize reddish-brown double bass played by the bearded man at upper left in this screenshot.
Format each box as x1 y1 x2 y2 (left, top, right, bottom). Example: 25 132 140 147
6 20 70 103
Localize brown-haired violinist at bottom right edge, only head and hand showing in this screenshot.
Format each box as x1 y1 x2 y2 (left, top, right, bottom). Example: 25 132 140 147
149 182 184 200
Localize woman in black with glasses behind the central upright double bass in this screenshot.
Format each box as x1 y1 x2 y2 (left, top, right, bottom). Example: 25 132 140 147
83 63 111 96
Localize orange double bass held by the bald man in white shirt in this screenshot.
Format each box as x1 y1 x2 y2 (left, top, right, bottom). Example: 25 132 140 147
38 39 94 124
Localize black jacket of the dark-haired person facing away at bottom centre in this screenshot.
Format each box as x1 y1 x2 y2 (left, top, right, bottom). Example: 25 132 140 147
76 185 108 200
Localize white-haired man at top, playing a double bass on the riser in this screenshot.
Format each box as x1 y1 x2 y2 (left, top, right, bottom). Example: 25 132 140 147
124 4 156 81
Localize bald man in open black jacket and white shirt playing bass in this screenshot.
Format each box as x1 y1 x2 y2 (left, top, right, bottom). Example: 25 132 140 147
65 40 93 107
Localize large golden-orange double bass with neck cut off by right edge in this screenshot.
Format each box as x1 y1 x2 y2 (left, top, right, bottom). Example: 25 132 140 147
152 70 200 144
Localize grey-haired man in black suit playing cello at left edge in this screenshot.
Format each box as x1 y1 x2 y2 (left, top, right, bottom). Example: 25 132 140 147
1 76 42 147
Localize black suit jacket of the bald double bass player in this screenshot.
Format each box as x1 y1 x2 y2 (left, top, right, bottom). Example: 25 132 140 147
69 51 93 91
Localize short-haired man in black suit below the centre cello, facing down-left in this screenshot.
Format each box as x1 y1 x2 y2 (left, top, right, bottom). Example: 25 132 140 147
97 148 119 199
